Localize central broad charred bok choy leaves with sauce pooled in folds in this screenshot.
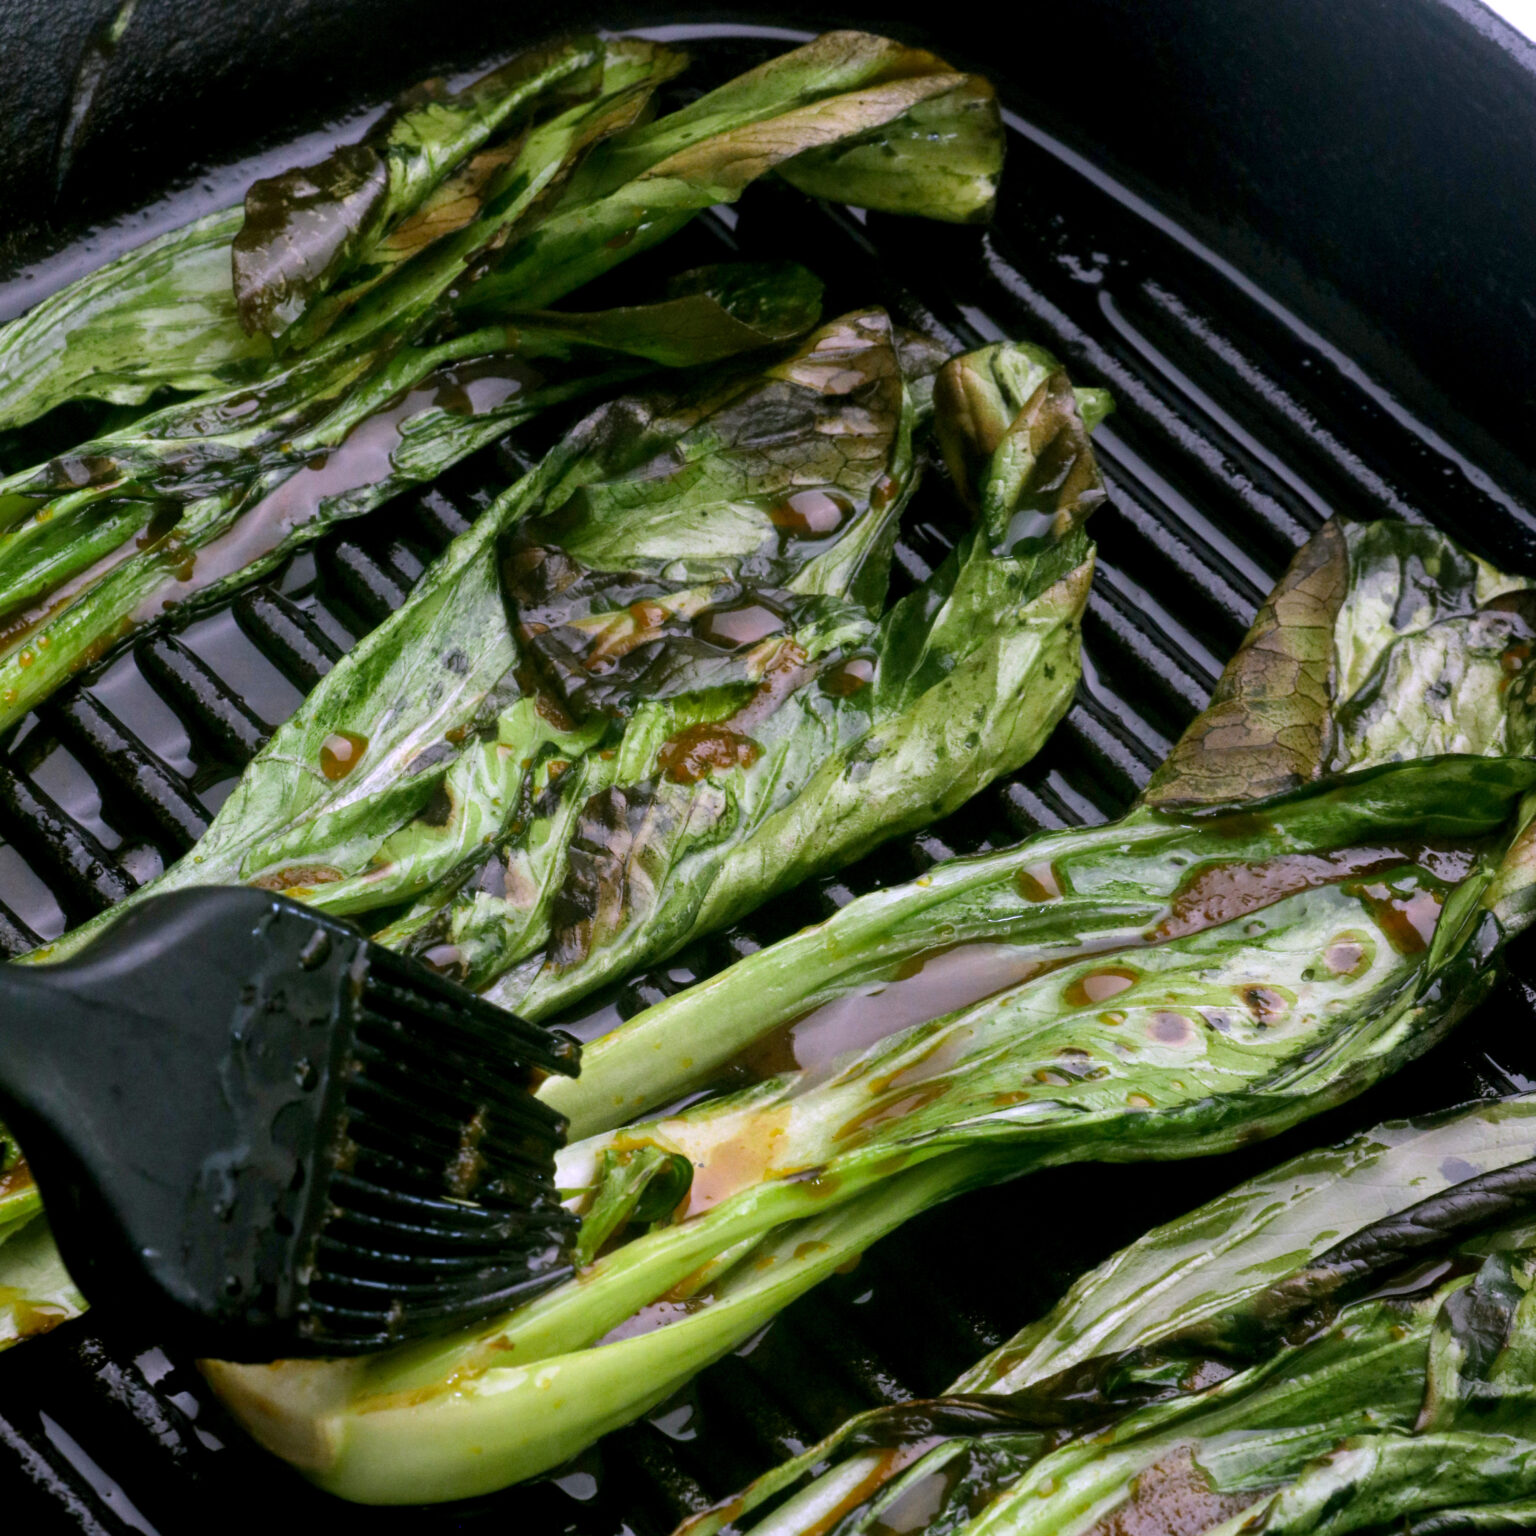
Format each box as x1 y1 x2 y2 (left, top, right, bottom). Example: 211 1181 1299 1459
29 327 1107 1015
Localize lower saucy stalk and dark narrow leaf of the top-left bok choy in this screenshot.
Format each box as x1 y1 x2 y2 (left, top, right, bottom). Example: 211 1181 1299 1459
0 263 820 727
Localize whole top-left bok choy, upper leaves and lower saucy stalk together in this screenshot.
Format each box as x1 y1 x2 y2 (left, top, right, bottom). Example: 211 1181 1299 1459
0 32 1001 728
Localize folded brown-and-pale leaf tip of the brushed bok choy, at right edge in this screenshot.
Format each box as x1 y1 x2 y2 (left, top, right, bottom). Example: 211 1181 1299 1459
1141 522 1536 809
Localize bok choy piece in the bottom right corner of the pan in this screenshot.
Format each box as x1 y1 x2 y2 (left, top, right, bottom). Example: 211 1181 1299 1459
679 1095 1536 1536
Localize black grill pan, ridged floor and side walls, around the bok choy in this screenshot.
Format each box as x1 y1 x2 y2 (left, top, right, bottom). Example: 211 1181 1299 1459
0 0 1536 1536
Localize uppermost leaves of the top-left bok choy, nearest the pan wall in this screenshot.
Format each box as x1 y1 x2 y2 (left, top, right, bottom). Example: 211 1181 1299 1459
0 32 1003 427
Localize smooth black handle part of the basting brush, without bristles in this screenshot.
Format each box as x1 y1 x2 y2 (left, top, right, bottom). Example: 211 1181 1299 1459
0 888 367 1349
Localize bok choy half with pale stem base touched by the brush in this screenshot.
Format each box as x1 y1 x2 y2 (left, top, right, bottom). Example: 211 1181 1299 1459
201 516 1536 1502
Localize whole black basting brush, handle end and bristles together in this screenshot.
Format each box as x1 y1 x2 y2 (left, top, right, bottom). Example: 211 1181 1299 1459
0 888 579 1359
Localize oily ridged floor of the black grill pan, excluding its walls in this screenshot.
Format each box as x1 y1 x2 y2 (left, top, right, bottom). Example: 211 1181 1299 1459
0 11 1536 1536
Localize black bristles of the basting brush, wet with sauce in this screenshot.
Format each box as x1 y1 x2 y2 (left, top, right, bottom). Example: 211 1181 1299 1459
290 951 579 1353
